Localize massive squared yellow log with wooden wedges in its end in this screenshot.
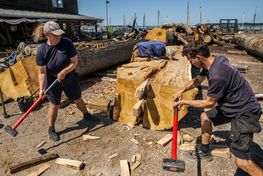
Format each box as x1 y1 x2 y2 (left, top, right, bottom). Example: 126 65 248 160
113 48 197 130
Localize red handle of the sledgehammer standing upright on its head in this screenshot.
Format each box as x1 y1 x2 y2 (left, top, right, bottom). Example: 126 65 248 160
171 107 178 160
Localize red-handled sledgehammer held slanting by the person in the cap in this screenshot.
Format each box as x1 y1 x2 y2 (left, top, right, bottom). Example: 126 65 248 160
4 80 58 137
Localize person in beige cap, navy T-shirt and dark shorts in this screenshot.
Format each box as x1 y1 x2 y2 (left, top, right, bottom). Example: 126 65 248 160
36 21 99 141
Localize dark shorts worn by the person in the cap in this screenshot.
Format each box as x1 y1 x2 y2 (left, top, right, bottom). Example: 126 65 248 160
46 73 81 105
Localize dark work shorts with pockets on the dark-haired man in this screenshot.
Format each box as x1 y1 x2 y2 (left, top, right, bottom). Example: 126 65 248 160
206 108 261 160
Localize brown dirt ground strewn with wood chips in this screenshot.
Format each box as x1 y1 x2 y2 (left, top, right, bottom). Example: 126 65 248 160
0 46 263 176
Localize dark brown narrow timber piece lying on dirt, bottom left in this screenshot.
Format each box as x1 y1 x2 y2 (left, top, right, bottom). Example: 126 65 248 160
9 153 58 174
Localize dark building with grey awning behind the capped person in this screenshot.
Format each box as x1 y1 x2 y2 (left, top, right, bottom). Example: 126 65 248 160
0 0 103 47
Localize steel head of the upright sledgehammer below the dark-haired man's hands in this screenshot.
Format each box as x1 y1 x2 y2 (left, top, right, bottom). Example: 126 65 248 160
163 158 185 172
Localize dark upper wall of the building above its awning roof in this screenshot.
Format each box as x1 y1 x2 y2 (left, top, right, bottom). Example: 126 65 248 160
0 0 78 14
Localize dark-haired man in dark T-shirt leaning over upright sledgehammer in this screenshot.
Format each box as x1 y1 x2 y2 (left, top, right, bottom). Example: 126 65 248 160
173 41 263 175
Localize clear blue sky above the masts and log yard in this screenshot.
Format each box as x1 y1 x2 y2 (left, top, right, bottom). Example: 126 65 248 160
78 0 263 26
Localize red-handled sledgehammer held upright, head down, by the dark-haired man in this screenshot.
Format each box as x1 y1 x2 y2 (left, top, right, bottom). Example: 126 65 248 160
163 107 185 172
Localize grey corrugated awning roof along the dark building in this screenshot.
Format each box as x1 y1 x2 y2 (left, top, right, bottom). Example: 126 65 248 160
0 8 103 22
